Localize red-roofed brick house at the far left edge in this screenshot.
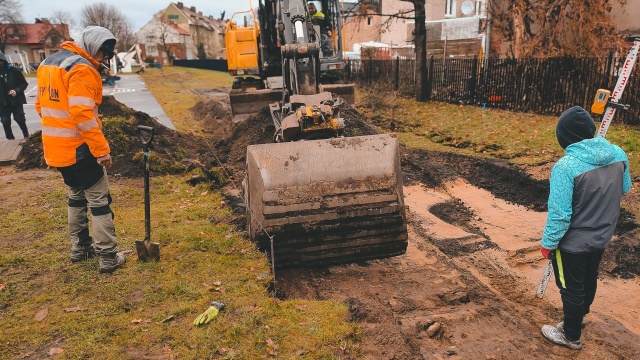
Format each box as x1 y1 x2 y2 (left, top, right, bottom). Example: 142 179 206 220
0 19 70 65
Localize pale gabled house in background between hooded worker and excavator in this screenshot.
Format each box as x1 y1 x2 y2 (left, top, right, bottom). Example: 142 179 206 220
136 2 226 63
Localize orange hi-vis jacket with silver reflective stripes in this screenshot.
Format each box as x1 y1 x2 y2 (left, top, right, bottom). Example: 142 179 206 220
36 41 110 167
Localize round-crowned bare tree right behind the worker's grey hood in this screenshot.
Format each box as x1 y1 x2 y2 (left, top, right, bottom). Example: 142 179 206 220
80 2 136 51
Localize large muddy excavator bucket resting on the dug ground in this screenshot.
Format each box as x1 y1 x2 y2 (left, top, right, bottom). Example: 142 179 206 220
244 135 407 268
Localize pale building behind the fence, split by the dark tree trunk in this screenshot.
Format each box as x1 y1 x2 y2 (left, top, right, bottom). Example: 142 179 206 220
343 0 489 58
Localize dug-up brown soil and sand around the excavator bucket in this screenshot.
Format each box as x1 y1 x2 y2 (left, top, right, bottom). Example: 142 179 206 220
19 97 640 359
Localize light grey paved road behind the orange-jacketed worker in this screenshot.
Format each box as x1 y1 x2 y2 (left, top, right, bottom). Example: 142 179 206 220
0 74 175 139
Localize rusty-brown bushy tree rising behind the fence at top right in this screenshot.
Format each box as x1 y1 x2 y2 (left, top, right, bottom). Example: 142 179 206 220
490 0 627 58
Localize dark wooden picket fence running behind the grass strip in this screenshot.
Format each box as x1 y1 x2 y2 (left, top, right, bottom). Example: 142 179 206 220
345 56 640 125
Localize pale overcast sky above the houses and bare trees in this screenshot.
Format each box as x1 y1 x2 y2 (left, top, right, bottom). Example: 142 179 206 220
19 0 248 31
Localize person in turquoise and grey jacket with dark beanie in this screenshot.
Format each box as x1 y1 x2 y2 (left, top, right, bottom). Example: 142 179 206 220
541 106 631 350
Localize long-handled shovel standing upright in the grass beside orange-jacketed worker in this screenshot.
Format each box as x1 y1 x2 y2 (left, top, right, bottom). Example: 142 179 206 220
136 125 160 261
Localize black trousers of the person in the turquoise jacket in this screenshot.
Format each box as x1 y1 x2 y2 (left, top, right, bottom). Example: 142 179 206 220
553 250 604 341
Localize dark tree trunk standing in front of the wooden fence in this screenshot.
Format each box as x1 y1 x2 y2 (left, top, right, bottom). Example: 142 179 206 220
412 0 429 101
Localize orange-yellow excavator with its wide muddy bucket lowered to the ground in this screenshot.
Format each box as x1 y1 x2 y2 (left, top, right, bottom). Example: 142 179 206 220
225 0 408 268
